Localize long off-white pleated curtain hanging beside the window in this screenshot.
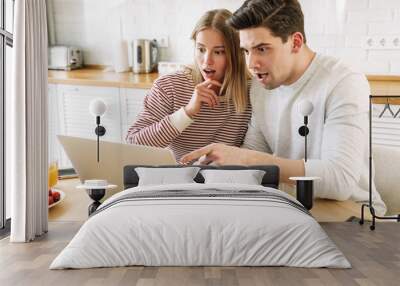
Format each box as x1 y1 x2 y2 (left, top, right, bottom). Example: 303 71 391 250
6 0 48 242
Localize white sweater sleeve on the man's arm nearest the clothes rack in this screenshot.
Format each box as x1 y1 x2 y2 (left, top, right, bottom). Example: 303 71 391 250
305 74 370 200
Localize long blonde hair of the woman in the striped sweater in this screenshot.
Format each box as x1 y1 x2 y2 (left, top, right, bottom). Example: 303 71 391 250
191 9 249 112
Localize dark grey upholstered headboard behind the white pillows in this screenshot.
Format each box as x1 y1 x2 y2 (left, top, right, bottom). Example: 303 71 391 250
124 165 279 189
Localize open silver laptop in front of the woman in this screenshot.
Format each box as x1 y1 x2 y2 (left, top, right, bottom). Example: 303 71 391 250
57 135 178 197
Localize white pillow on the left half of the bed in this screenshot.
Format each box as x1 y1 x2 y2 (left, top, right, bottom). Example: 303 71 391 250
135 167 200 186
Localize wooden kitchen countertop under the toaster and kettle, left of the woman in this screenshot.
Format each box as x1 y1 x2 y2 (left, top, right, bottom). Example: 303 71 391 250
48 67 158 89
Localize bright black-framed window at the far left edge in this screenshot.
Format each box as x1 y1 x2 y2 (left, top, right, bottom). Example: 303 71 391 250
0 0 14 232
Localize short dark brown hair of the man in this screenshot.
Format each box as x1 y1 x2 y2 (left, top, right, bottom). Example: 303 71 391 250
228 0 306 43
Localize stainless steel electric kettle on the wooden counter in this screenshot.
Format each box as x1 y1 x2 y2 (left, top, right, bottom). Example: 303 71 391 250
132 39 159 73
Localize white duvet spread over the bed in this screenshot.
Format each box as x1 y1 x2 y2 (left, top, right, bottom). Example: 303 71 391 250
50 184 351 269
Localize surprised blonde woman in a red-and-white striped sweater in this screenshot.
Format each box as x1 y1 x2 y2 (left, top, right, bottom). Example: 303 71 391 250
126 9 251 161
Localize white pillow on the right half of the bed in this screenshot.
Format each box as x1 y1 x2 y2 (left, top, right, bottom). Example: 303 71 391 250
200 169 265 185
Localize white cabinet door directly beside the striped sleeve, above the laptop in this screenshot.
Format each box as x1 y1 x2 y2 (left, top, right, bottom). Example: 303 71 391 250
120 88 149 142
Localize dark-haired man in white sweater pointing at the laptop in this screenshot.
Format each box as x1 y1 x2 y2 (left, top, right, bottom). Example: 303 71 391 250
181 0 386 215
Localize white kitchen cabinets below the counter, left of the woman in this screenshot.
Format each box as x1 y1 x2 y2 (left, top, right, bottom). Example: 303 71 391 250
48 84 148 169
